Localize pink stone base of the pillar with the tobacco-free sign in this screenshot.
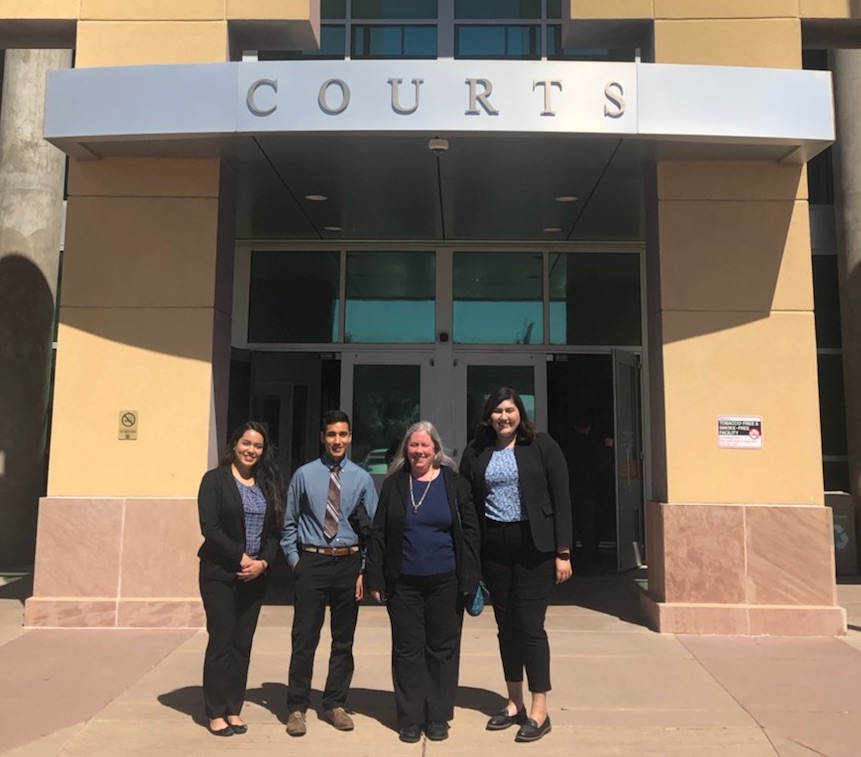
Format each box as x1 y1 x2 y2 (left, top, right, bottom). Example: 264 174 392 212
642 502 846 636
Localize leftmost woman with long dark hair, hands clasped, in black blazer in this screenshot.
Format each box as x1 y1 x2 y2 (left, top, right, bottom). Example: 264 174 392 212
197 421 284 736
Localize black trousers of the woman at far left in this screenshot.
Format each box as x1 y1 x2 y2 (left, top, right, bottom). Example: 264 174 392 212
199 575 268 718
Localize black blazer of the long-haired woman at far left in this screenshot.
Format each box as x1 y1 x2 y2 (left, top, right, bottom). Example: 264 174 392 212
197 465 281 581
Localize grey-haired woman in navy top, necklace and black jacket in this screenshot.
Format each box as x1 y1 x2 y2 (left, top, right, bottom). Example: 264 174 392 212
365 421 479 743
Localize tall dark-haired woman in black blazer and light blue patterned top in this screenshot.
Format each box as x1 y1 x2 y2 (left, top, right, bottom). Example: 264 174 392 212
460 387 572 741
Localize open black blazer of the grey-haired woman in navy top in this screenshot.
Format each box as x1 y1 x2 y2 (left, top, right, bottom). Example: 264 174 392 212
365 466 481 594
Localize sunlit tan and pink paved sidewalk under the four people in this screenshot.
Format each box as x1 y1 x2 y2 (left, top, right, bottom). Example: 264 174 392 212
0 576 861 757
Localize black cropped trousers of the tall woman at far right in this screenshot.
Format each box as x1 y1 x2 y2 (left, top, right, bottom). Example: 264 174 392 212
481 520 556 692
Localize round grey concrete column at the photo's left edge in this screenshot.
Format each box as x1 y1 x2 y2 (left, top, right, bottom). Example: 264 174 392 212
0 50 72 565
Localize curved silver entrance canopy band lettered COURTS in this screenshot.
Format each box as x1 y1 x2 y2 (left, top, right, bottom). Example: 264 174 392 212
45 59 834 157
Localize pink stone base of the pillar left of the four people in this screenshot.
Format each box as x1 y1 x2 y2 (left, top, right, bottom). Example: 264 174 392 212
24 497 205 628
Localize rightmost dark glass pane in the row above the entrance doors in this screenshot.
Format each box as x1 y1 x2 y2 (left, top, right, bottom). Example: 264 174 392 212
550 253 642 346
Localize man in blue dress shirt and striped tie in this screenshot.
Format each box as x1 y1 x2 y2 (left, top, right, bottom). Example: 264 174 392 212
281 410 377 736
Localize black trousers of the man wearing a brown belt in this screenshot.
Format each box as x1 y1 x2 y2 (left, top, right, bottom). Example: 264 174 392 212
287 552 362 712
